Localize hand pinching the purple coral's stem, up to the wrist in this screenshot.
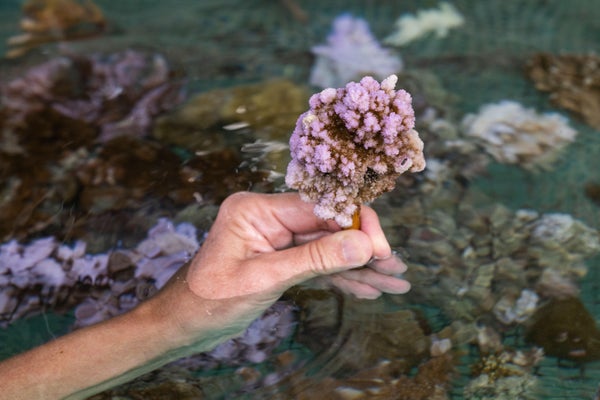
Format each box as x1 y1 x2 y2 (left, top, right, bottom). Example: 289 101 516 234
152 193 410 346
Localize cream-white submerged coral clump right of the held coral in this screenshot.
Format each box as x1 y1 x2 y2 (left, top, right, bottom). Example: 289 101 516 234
462 100 577 170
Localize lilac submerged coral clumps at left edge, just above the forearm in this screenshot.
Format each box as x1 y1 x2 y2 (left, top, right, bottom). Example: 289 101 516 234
0 220 199 325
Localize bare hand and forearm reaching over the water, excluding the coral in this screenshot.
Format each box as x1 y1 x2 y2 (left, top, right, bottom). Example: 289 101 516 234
0 193 409 399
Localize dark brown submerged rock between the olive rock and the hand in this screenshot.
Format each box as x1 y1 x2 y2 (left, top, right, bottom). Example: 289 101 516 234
75 136 272 219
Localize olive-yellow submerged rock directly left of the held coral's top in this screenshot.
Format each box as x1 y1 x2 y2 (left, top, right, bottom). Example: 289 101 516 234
152 79 309 148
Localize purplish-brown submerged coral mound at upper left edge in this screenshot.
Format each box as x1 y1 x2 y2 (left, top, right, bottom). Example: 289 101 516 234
2 50 183 141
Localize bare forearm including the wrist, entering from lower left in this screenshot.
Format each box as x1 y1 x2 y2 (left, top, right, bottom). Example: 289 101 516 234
0 270 237 400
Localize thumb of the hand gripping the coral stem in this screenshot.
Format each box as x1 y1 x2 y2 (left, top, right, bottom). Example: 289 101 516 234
265 229 373 287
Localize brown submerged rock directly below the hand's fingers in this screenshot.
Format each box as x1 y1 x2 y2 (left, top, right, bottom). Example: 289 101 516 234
290 289 431 372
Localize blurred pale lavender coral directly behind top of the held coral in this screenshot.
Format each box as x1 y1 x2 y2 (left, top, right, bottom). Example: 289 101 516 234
309 14 402 88
